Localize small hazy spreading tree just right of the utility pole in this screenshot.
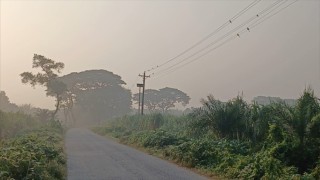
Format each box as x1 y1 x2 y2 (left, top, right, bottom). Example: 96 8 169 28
133 87 190 112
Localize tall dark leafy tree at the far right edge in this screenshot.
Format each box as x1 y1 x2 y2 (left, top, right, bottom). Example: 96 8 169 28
290 88 320 172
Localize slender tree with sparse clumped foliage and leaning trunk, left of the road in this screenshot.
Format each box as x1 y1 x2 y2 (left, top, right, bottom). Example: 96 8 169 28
20 54 66 119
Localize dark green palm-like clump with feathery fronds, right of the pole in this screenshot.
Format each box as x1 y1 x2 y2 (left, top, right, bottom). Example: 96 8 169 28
191 95 250 141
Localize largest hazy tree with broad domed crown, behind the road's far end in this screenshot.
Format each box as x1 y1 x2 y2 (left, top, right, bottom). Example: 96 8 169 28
59 70 131 122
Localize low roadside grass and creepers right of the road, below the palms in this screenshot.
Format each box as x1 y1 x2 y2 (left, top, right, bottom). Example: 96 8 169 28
92 105 320 180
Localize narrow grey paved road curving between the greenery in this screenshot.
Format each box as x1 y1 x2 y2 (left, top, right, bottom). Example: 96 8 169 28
66 128 206 180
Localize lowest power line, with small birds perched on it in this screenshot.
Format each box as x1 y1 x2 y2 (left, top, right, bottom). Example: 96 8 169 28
151 0 298 77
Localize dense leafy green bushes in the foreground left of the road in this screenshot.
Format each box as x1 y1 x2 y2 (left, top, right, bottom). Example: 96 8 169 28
0 130 66 179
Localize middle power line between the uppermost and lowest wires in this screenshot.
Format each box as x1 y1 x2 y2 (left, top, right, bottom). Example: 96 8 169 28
153 0 287 75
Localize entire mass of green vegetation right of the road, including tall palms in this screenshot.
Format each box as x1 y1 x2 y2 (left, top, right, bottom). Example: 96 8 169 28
94 89 320 179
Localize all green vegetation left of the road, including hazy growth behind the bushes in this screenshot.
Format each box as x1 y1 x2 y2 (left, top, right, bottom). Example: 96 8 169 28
0 111 66 179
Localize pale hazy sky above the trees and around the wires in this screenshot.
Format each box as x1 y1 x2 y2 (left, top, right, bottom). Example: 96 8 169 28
0 0 320 108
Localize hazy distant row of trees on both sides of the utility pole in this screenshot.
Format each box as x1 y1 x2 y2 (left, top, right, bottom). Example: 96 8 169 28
20 54 190 124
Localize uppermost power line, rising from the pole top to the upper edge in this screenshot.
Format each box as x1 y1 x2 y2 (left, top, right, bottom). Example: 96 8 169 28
146 0 261 72
